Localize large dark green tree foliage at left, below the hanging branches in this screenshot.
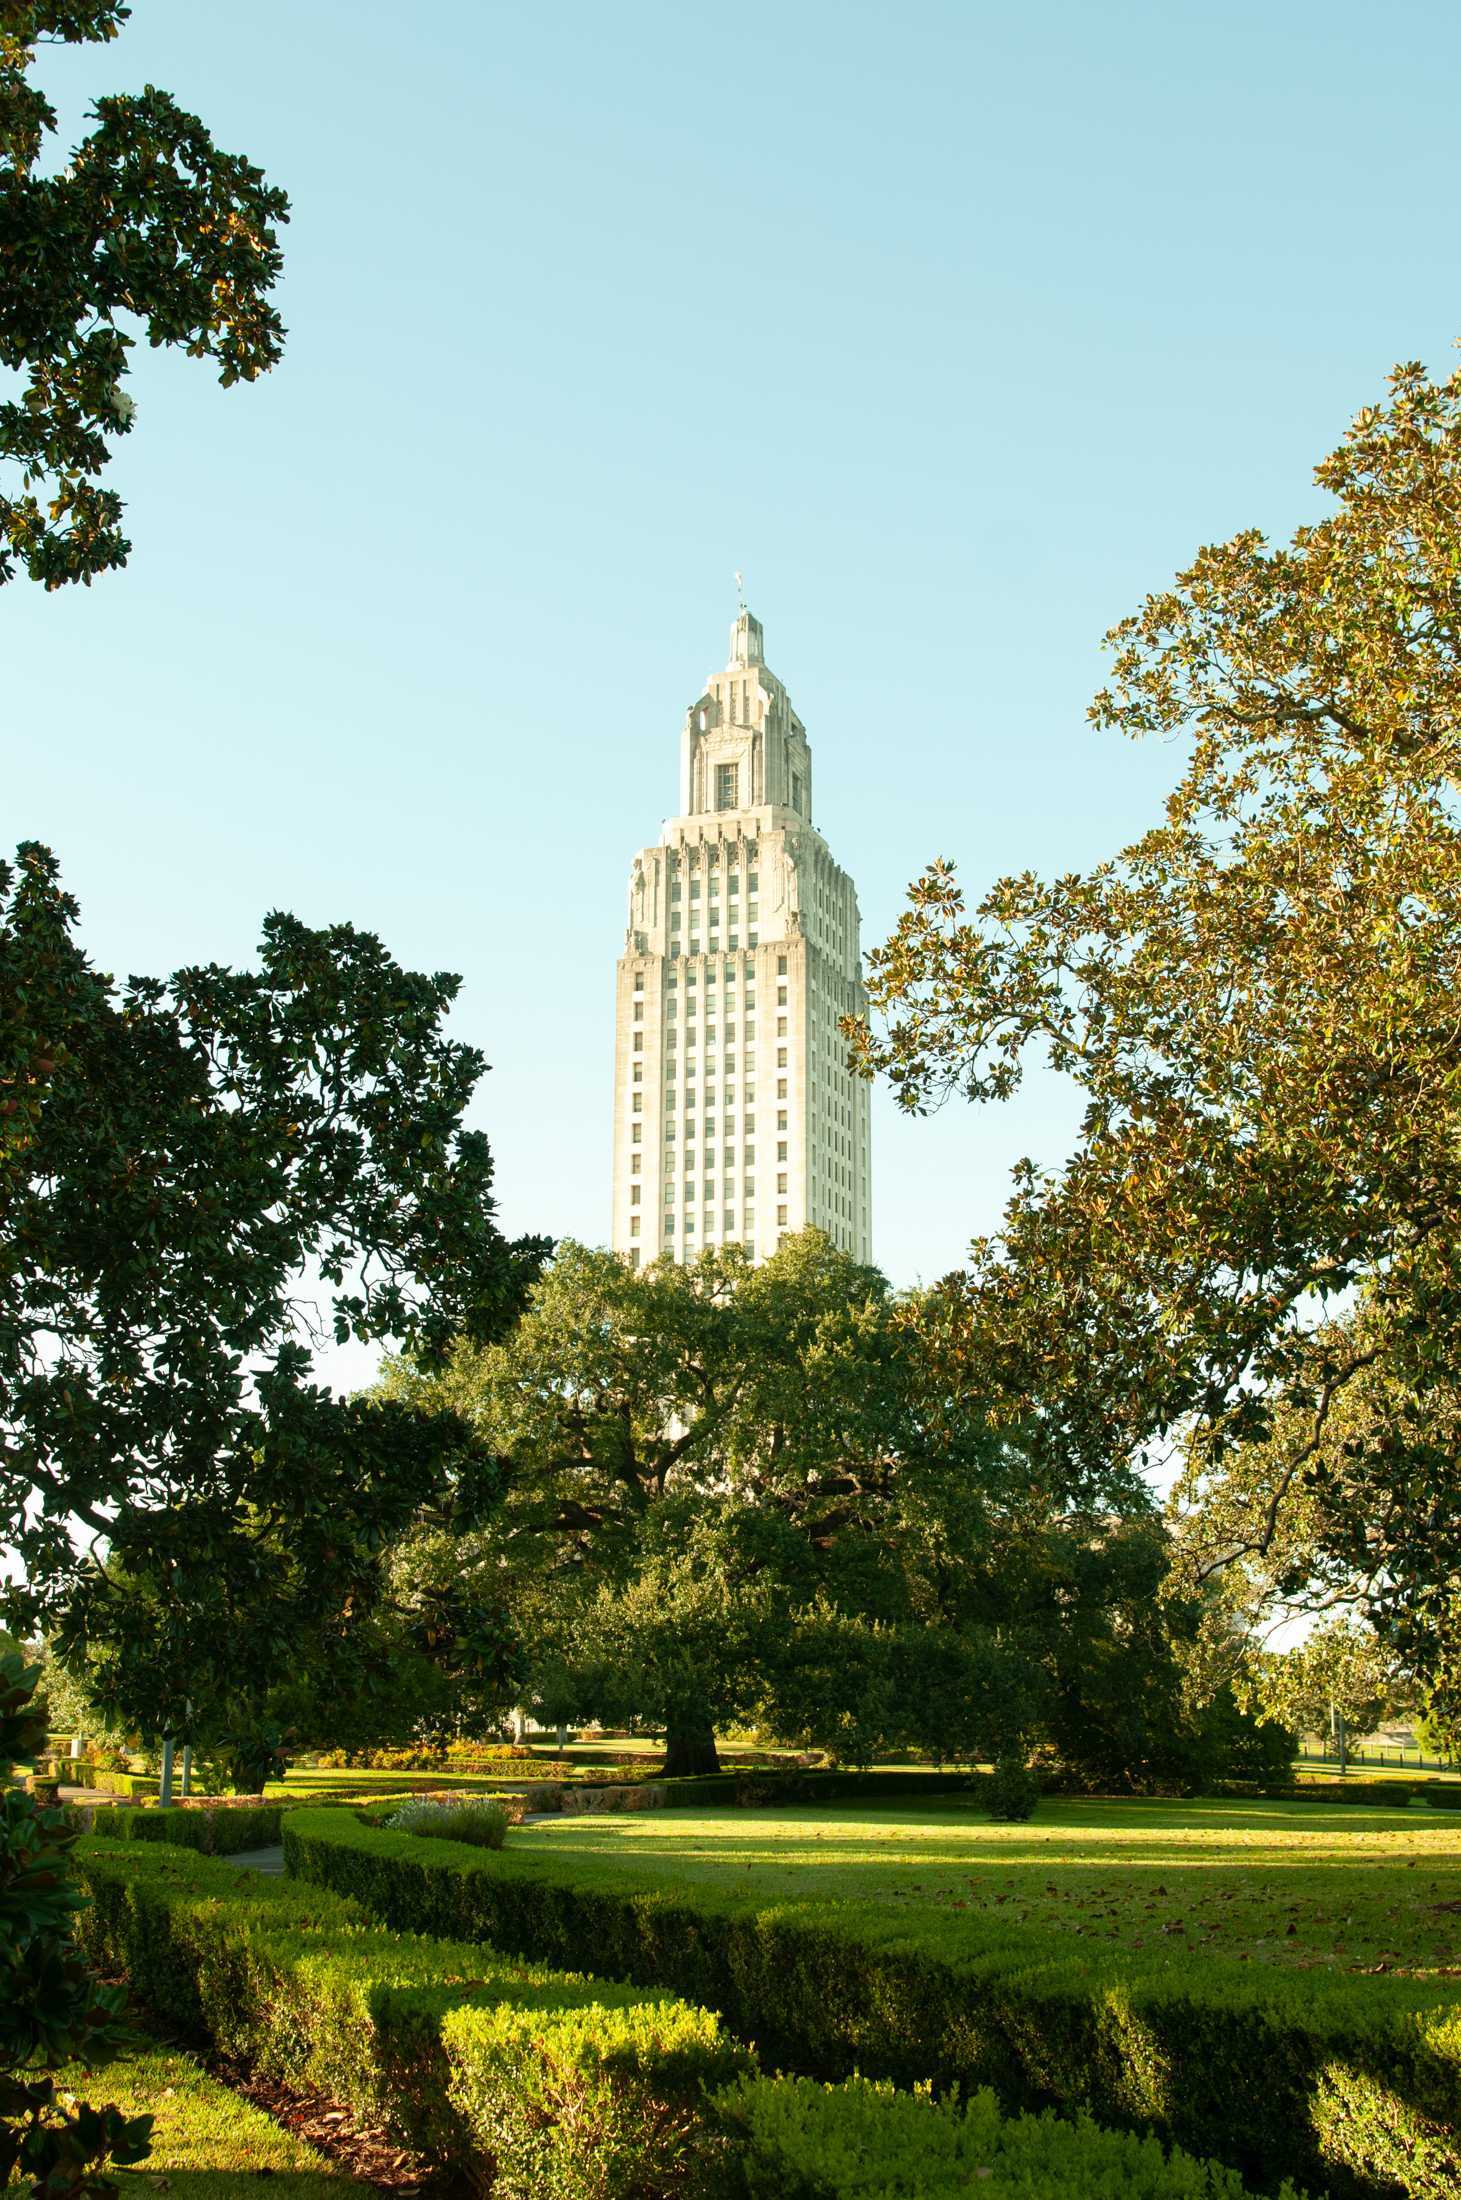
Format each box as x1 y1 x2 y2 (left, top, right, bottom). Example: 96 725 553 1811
0 845 543 1736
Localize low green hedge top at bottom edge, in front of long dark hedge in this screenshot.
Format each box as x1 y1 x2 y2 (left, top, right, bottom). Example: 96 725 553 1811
717 2077 1296 2200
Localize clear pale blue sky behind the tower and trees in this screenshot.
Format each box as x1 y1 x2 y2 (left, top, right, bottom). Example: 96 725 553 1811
11 0 1461 1283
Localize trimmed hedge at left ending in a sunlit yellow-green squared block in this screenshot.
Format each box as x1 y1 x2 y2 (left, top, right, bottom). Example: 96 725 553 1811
79 1813 750 2200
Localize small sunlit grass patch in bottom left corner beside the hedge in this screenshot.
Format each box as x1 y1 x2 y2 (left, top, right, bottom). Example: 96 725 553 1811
62 2048 372 2200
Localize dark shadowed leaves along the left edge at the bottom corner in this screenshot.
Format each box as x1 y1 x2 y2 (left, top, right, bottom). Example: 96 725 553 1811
0 1654 152 2200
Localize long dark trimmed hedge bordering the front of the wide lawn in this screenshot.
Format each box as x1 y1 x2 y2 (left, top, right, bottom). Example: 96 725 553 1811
284 1811 1461 2200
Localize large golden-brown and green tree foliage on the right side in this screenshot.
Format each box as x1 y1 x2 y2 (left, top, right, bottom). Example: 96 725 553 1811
854 365 1461 1670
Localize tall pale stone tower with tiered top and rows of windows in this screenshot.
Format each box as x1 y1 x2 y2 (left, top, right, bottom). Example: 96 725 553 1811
614 609 871 1267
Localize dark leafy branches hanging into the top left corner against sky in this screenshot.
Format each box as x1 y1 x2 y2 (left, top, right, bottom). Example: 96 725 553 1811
0 0 288 587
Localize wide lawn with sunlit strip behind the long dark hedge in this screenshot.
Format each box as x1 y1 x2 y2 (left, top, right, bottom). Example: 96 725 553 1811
508 1802 1461 1982
